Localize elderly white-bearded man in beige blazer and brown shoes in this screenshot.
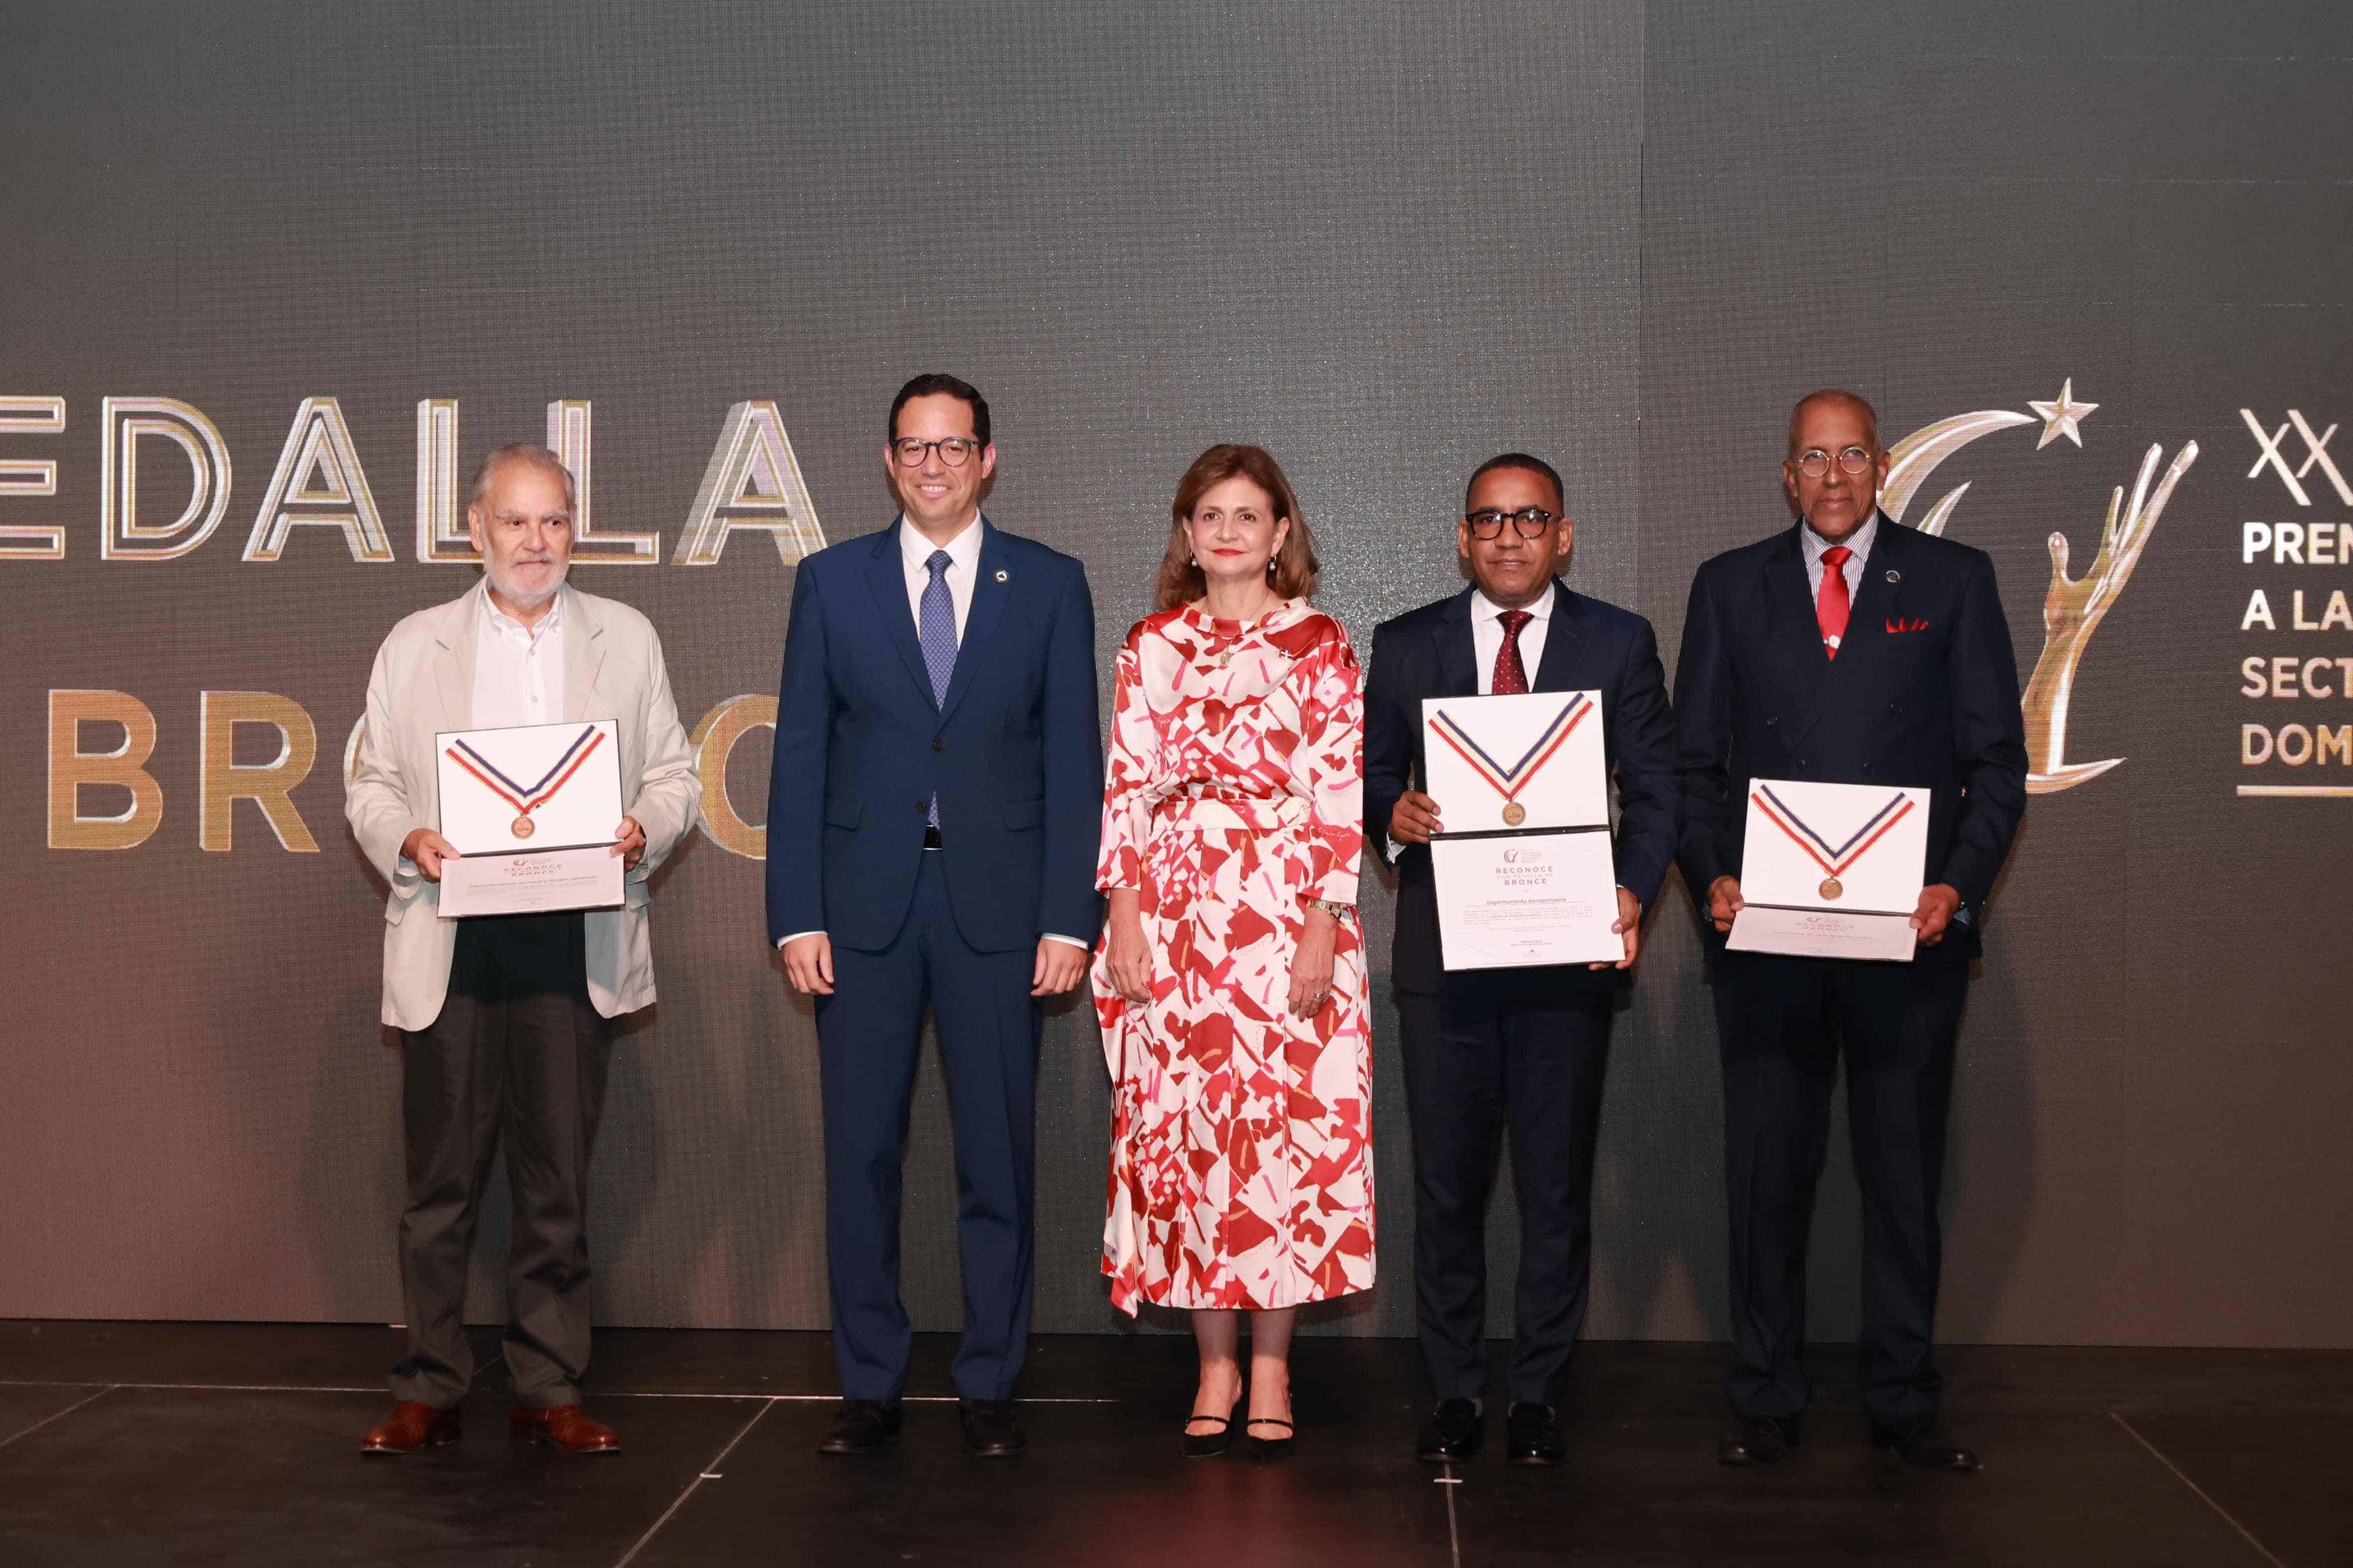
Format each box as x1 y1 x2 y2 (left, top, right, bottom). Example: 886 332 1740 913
343 444 701 1453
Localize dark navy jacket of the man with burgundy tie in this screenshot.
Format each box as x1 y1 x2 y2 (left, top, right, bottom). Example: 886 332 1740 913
1365 578 1675 992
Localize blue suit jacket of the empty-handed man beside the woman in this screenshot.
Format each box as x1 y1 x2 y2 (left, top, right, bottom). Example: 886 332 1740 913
767 517 1104 952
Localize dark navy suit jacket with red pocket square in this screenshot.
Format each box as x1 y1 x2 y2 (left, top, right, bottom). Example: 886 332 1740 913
1675 512 2026 959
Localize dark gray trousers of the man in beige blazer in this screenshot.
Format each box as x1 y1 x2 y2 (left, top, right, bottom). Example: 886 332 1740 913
391 914 612 1410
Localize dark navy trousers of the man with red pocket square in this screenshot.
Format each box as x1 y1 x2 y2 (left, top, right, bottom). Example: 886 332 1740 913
1716 952 1970 1424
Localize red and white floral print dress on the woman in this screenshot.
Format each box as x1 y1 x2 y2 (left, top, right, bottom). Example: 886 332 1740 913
1094 599 1374 1314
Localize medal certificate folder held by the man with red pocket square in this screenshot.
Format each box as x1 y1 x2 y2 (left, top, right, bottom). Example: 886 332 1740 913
1727 778 1929 961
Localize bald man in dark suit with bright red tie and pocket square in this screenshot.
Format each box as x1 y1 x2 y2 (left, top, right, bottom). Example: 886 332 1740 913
1675 390 2026 1472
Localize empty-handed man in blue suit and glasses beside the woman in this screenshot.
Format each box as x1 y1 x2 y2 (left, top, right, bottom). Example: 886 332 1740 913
767 376 1104 1458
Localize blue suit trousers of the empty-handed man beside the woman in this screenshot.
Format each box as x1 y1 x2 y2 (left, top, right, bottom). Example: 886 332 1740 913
817 851 1040 1401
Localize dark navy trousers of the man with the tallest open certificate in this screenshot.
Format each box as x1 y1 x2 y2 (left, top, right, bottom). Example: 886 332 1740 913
1398 975 1609 1403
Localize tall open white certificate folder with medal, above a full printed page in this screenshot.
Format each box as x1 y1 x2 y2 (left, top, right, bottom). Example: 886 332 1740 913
1421 691 1626 971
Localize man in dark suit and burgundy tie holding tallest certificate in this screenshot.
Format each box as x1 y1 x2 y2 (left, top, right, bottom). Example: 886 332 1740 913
1365 451 1675 1465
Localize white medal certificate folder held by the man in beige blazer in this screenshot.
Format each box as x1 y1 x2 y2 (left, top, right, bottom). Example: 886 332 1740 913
436 719 623 919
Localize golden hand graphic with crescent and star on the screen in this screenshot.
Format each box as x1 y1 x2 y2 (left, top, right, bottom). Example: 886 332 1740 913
1880 378 2197 794
